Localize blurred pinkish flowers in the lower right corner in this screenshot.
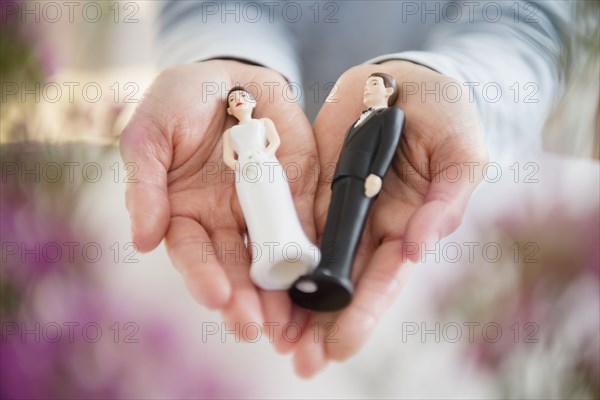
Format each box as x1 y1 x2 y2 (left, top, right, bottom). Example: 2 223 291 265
436 200 600 397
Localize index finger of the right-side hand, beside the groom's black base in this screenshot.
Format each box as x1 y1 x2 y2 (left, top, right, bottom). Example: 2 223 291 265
324 240 412 361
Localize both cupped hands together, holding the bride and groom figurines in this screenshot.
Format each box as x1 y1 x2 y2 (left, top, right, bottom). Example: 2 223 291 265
121 61 485 375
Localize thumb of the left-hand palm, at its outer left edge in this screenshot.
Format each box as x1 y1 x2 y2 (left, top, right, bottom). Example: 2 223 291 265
120 120 172 252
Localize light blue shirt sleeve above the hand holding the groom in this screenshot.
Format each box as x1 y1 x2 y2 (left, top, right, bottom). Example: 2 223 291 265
367 1 574 158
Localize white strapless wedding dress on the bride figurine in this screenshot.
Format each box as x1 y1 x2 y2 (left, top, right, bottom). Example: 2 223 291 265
230 119 320 290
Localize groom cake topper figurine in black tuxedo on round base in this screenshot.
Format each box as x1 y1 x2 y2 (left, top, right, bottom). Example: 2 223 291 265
289 73 404 311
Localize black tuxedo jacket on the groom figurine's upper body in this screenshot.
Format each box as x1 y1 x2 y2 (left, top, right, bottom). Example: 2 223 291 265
332 107 404 184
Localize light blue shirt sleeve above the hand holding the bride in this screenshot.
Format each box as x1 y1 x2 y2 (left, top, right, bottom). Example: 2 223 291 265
158 0 300 82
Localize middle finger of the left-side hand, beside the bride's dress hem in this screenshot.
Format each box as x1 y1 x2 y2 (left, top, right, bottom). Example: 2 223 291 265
211 229 263 334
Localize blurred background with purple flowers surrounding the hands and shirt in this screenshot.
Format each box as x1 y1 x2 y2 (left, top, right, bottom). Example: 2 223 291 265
0 0 600 399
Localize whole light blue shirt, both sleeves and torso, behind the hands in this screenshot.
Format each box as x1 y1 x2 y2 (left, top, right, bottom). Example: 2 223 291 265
159 0 576 159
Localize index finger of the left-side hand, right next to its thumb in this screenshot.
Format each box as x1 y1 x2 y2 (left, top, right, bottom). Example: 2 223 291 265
166 217 231 309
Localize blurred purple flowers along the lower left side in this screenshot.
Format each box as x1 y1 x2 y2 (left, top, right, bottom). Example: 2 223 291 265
0 143 247 399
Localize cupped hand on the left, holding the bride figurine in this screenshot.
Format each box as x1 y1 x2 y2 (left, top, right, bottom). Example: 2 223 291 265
120 60 318 342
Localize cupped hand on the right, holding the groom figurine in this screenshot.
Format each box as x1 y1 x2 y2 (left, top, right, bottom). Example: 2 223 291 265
294 61 487 376
